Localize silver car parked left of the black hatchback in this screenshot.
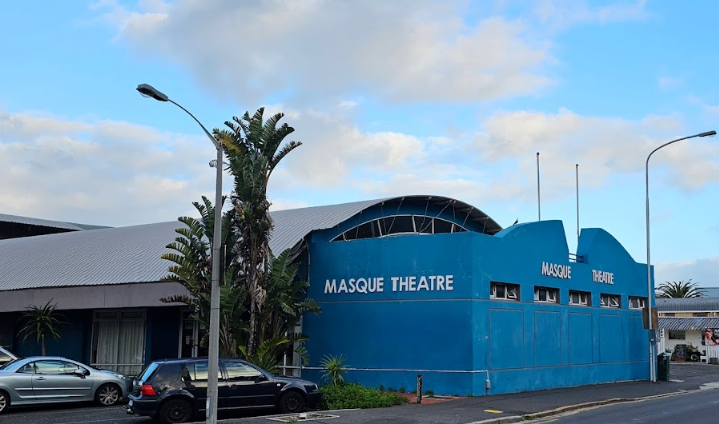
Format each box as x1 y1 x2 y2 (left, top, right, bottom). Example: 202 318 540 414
0 356 132 413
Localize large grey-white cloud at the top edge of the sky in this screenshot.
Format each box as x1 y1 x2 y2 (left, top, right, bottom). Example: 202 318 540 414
98 0 550 102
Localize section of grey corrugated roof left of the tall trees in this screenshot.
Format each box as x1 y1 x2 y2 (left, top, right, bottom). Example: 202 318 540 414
0 221 182 290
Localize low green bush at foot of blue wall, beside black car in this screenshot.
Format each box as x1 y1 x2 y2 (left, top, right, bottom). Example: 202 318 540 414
320 384 407 409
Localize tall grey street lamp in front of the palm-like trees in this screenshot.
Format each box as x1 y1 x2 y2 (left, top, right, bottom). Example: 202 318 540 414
137 84 222 424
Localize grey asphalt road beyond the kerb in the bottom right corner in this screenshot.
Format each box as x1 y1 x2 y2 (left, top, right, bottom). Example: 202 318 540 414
525 390 719 424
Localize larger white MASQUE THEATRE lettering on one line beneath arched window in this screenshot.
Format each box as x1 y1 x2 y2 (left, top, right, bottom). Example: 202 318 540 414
325 275 454 294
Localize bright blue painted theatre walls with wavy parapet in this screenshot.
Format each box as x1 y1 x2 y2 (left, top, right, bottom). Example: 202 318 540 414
303 212 649 396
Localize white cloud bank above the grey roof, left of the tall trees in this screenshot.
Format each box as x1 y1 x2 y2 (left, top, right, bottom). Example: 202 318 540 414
0 111 214 225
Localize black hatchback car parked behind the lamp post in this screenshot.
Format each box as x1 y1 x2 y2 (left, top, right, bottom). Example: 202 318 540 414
125 358 320 424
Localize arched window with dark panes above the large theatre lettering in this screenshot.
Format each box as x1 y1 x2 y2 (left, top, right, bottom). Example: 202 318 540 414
332 215 467 241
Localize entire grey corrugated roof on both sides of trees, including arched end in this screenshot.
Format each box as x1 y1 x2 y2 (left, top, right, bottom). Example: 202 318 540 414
0 196 501 291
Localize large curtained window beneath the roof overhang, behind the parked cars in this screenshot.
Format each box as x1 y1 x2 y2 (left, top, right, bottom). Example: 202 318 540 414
91 310 145 375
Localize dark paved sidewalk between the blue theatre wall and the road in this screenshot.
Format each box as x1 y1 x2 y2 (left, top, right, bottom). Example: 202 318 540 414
217 363 719 424
